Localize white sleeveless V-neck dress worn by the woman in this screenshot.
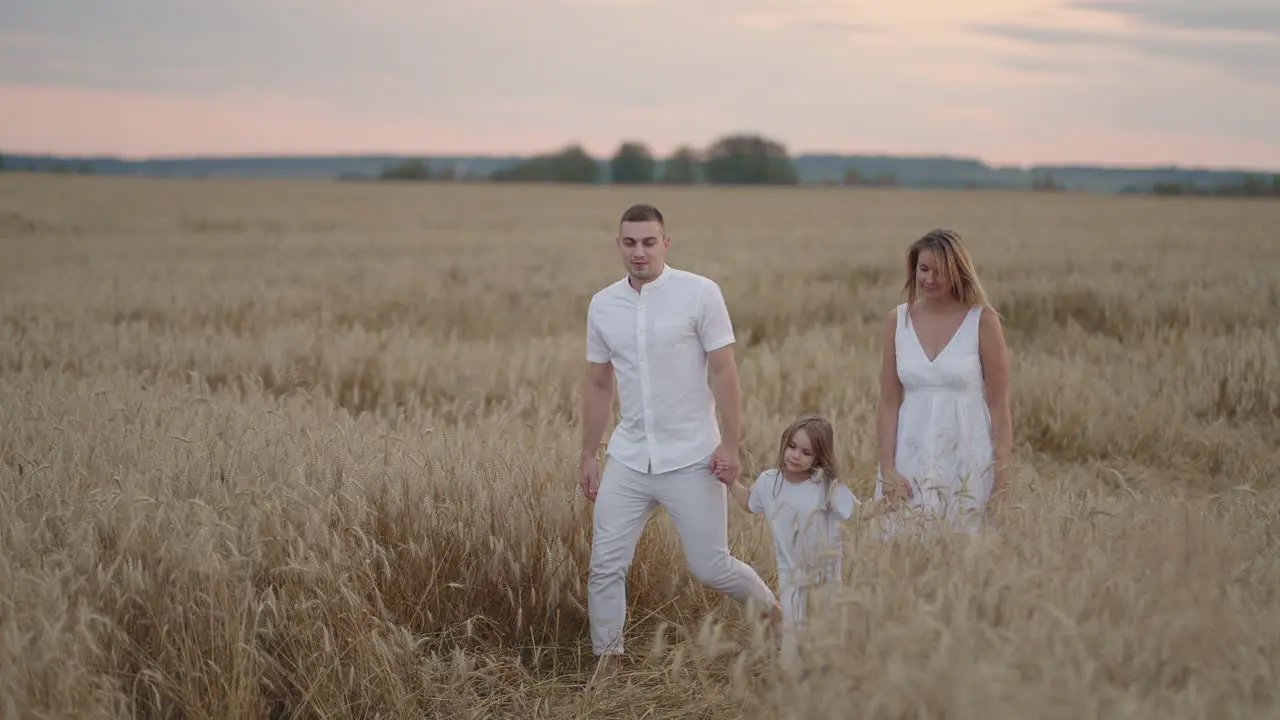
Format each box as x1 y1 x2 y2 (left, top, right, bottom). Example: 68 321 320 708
874 302 995 538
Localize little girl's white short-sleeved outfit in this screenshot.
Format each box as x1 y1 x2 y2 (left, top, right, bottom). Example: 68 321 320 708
746 469 859 630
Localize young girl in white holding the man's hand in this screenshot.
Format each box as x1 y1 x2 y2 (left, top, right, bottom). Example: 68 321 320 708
716 414 859 630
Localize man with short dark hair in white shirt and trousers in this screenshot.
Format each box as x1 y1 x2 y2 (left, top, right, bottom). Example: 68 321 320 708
581 199 781 676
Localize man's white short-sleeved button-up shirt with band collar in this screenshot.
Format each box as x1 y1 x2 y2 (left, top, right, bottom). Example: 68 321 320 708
586 265 733 473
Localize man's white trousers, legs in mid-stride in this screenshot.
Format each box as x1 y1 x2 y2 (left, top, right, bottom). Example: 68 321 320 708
586 456 774 655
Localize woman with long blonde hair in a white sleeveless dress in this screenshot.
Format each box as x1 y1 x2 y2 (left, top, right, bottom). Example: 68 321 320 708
876 229 1012 537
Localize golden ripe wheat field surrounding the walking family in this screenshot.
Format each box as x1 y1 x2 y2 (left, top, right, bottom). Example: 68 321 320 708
0 176 1280 720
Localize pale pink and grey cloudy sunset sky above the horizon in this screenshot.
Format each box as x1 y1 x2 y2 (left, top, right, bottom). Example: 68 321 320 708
0 0 1280 170
